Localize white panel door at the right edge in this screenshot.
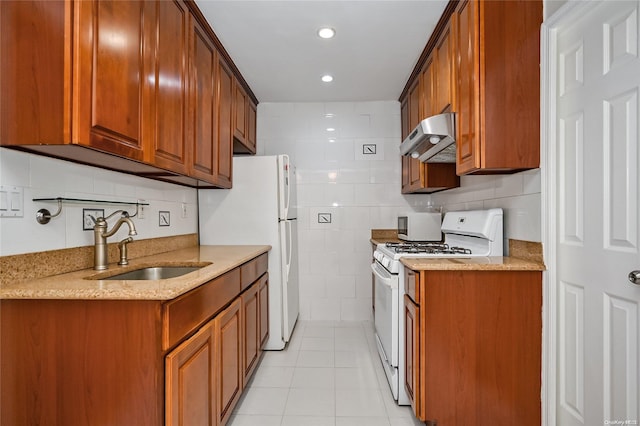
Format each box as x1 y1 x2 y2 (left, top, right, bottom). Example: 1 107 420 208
550 0 640 425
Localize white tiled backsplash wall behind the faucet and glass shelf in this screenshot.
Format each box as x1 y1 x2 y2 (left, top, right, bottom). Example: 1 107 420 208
0 148 198 256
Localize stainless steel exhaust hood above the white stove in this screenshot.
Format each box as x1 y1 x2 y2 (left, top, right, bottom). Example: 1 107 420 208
400 112 456 163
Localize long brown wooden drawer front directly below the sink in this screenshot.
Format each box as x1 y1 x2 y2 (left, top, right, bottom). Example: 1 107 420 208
162 268 240 350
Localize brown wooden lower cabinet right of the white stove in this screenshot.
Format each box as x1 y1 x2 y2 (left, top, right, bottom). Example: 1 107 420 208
405 271 542 426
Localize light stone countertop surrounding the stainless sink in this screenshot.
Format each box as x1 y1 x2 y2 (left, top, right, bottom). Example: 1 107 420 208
0 245 271 300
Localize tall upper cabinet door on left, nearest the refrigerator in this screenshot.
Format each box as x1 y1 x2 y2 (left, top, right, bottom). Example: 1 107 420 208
215 55 234 188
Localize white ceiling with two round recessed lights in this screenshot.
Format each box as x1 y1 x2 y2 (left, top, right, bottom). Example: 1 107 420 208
196 0 447 102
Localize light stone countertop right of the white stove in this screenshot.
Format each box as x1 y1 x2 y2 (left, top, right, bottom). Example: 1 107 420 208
400 256 545 271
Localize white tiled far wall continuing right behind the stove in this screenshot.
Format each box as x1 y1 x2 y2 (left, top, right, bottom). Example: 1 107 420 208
258 101 540 320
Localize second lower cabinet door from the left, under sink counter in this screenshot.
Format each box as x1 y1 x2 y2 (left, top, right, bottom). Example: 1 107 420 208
215 298 243 424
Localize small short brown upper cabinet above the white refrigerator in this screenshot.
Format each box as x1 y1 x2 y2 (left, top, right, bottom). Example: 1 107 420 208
233 80 256 154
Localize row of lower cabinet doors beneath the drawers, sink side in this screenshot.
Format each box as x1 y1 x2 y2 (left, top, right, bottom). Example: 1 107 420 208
166 273 268 426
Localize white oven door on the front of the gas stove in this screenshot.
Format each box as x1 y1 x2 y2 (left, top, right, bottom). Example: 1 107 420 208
371 262 399 367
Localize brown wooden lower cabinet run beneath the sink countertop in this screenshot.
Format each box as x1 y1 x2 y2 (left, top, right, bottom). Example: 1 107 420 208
0 255 268 426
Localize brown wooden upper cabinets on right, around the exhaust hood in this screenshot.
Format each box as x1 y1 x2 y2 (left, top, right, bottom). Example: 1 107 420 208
400 0 542 186
